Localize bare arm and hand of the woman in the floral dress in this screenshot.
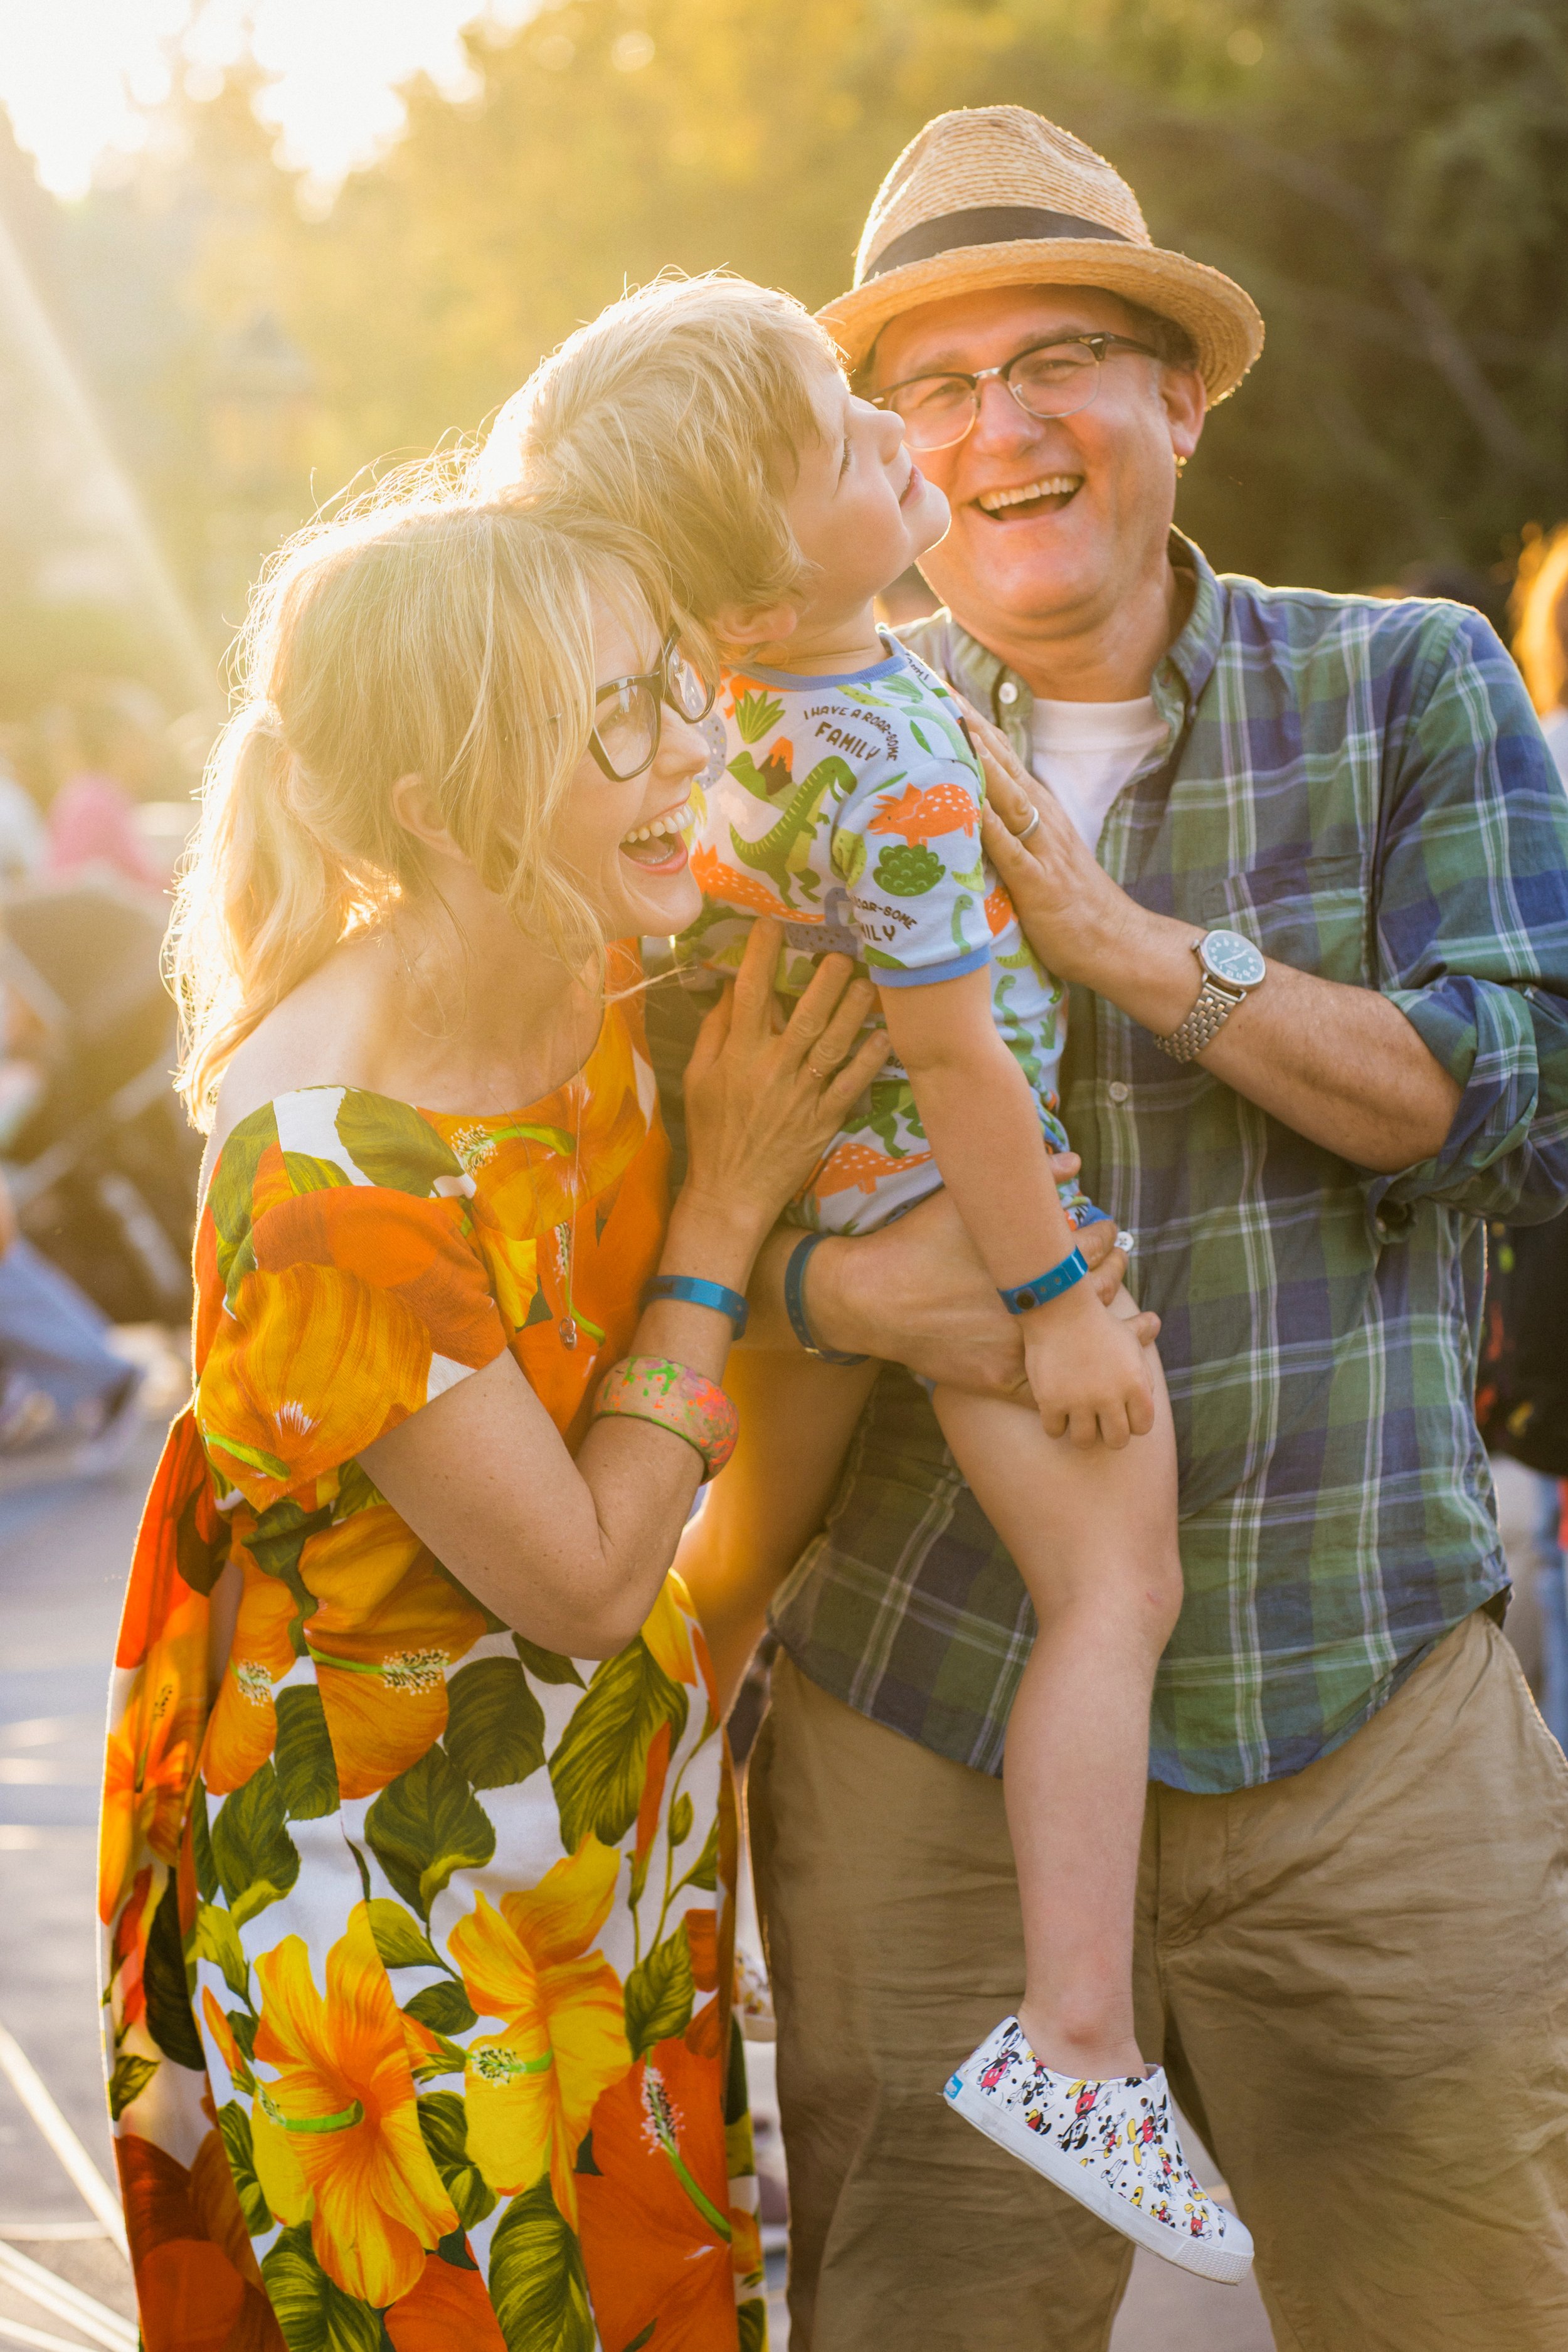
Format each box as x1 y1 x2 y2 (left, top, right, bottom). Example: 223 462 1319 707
359 924 886 1658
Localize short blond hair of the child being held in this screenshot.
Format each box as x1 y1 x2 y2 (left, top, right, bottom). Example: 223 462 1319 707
480 273 837 626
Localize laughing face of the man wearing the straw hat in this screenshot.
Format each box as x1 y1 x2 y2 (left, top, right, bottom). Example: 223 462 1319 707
870 287 1204 649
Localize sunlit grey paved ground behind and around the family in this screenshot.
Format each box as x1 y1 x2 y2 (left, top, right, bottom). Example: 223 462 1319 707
0 1380 1528 2352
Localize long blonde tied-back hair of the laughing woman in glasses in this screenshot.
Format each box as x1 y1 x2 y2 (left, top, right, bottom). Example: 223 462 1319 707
169 468 667 1126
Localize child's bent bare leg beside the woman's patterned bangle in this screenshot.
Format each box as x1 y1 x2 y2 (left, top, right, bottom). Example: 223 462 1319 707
675 1348 879 1712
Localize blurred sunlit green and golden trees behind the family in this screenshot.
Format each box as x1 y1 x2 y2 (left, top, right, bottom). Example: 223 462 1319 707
9 0 1568 649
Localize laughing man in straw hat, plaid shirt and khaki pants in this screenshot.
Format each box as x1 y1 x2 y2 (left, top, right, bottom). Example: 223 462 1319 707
714 109 1568 2352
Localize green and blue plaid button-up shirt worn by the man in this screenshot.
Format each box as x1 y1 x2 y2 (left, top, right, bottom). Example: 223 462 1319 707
653 539 1568 1790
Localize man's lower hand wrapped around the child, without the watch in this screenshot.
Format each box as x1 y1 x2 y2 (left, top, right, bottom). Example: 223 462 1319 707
745 1176 1159 1402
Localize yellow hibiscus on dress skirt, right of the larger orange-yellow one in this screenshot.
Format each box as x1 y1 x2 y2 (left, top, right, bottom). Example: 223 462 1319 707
447 1837 632 2227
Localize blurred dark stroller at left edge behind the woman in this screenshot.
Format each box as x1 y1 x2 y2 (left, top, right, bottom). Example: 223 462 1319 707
0 868 202 1324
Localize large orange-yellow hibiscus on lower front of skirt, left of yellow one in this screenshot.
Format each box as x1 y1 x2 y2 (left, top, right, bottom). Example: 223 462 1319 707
257 1903 458 2305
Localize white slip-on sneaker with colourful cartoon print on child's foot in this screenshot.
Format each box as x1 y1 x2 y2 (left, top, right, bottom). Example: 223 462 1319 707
945 2018 1253 2286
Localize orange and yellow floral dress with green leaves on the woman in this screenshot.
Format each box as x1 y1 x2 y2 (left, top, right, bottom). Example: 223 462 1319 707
101 964 764 2352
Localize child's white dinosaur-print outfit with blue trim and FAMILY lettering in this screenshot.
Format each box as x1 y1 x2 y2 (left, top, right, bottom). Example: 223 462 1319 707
677 637 1103 1232
